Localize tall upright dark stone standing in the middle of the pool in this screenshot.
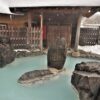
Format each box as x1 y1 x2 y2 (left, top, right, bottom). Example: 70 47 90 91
47 38 66 70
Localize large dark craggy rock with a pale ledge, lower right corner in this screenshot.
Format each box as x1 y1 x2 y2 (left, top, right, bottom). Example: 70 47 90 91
71 62 100 100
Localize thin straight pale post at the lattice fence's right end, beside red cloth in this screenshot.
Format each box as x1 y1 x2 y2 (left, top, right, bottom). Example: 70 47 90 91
40 14 43 52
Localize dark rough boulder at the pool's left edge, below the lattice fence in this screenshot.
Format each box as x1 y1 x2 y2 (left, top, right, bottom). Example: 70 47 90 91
0 37 15 67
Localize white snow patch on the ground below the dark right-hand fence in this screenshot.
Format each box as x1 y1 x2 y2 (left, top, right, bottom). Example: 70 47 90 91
78 45 100 54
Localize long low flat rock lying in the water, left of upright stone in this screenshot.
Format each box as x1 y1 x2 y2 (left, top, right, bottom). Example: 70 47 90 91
18 69 64 85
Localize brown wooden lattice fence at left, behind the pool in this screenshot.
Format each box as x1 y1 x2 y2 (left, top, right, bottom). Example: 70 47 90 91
0 26 40 49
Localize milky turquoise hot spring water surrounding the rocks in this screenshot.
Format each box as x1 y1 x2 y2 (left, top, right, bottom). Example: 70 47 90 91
0 55 99 100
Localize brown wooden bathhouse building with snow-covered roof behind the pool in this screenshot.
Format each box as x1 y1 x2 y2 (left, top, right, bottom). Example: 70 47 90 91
0 0 100 50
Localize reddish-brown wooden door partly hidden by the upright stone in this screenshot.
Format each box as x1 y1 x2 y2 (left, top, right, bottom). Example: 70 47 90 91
47 24 71 47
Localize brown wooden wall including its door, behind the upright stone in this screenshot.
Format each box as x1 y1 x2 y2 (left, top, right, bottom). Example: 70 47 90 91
44 12 79 47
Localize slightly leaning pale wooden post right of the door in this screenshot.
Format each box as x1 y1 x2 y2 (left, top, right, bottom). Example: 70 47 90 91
74 14 82 51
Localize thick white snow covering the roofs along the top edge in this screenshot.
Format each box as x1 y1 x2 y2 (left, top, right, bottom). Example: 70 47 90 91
0 0 100 13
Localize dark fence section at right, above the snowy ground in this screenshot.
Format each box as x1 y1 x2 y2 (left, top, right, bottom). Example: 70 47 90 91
79 27 100 46
